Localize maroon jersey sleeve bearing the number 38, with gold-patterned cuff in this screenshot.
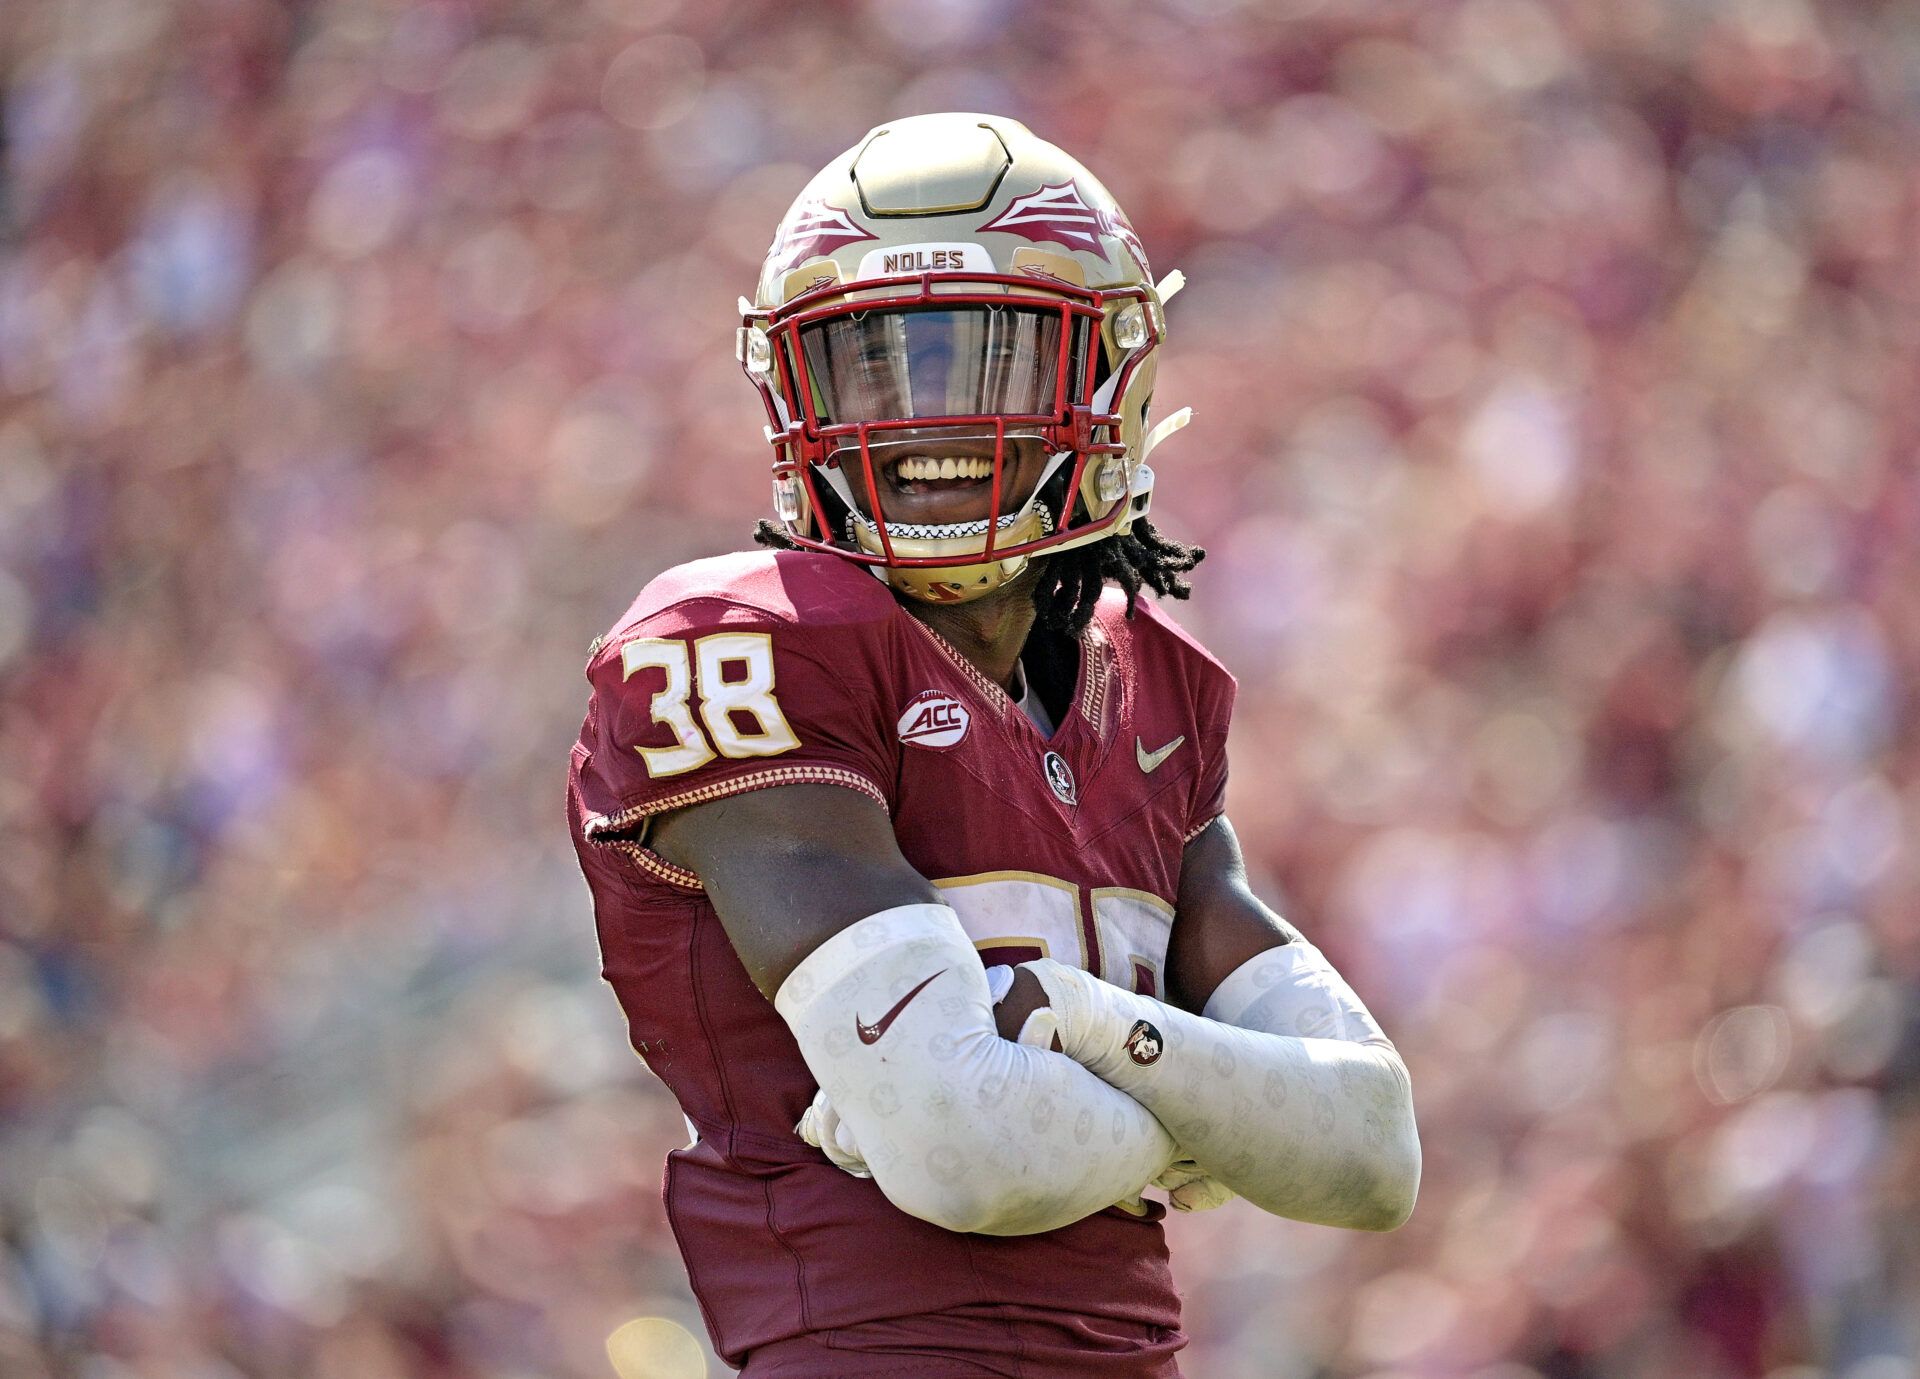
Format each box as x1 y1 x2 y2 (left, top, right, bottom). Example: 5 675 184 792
578 599 899 841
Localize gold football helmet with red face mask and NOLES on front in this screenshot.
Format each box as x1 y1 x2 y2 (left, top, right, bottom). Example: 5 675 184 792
739 115 1190 603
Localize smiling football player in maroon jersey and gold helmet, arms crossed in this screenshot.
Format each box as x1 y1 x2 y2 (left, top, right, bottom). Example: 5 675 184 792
568 115 1421 1379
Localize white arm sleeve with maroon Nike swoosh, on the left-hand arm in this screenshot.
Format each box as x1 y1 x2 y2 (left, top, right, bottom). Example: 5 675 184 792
774 905 1175 1235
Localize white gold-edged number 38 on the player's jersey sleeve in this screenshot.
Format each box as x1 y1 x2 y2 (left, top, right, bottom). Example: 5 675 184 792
620 632 801 778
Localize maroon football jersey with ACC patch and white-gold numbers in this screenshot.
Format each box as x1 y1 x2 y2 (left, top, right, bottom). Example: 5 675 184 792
568 551 1233 1377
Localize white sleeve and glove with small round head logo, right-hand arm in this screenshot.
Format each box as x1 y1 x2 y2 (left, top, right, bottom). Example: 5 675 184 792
1021 941 1421 1231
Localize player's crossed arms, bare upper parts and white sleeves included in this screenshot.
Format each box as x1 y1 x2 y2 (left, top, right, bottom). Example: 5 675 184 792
649 786 1419 1235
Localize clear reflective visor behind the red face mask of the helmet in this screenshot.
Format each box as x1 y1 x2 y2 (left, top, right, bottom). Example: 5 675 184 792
801 305 1089 426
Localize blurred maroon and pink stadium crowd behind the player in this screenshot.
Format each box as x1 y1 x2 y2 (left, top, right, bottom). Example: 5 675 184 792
0 0 1920 1379
